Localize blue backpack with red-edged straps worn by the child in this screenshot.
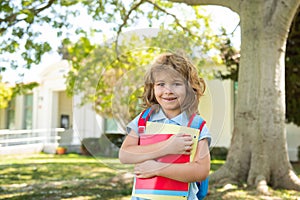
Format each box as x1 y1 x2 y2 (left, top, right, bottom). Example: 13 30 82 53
138 108 209 200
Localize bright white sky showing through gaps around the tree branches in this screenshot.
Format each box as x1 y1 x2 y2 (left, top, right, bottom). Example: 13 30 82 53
3 6 240 83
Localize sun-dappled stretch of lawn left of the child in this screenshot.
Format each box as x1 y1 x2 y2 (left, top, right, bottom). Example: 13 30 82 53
0 154 132 200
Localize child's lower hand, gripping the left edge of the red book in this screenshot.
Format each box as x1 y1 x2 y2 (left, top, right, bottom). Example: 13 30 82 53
134 160 162 178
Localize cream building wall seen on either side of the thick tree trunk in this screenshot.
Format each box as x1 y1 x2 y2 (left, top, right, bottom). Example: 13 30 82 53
200 80 300 161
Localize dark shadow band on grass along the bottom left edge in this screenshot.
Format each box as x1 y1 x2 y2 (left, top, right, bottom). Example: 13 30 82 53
2 180 131 200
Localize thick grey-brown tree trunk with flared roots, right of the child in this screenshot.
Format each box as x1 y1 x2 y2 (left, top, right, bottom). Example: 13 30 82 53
171 0 300 193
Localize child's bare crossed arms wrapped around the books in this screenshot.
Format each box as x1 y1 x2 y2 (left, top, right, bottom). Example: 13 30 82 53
119 131 210 182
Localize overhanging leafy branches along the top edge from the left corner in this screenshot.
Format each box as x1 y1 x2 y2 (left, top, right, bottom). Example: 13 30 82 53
0 0 216 70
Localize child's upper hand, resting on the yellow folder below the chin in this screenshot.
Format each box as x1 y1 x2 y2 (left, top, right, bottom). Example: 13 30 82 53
164 133 194 155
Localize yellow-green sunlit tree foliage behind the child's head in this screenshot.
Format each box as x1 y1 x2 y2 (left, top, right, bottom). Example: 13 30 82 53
61 7 220 127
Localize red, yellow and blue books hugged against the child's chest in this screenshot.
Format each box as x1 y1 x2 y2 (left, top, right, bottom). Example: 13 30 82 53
133 122 199 199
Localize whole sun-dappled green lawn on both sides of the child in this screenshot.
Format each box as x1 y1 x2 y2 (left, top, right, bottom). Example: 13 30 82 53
0 154 300 200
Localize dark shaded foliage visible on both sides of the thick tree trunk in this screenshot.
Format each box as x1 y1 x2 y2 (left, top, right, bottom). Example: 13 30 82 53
216 8 300 125
